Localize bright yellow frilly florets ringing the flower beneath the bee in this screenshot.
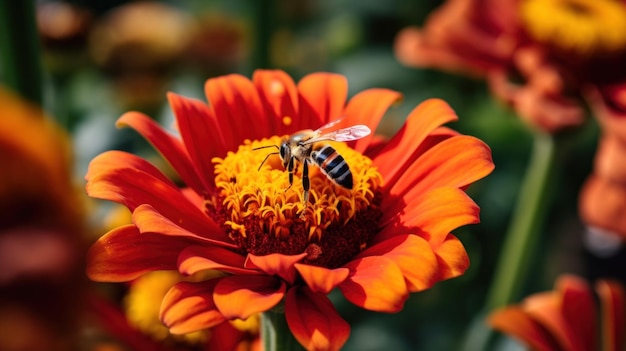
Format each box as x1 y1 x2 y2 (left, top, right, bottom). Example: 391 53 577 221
213 136 382 240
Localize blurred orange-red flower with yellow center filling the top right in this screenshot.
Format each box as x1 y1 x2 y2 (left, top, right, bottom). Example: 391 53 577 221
395 0 626 236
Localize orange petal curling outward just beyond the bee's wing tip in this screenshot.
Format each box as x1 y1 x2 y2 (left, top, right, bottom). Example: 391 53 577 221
341 89 402 153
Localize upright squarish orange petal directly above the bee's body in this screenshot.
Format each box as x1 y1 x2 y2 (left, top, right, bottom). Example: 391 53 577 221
295 72 348 129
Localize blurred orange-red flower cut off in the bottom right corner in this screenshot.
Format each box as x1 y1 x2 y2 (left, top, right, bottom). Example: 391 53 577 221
488 275 626 351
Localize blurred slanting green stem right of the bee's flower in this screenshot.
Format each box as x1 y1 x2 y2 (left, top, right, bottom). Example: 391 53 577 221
486 133 558 311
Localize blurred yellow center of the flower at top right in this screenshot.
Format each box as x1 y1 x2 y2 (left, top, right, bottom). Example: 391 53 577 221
521 0 626 57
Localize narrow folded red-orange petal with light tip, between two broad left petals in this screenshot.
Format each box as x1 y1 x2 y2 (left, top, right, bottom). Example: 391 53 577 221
133 204 232 248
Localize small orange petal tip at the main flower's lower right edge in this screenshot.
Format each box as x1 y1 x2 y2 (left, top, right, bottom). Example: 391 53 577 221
434 234 469 280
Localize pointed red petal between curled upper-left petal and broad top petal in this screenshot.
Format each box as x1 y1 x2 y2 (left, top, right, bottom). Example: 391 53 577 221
167 93 224 184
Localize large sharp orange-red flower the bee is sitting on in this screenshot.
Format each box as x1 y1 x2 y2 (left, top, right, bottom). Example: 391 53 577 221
86 70 493 350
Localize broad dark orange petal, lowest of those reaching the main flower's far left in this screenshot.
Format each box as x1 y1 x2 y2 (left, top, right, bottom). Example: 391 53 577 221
87 225 185 282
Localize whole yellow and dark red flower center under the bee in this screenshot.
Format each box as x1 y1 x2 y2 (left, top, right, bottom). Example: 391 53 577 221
206 136 382 268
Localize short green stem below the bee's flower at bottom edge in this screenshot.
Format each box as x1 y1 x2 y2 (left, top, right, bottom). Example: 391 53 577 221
261 311 302 351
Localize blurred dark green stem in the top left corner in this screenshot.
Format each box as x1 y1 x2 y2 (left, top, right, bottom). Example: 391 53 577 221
0 0 43 106
